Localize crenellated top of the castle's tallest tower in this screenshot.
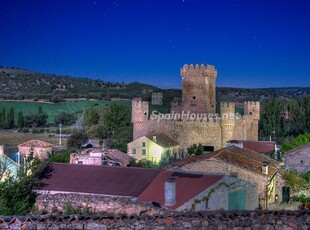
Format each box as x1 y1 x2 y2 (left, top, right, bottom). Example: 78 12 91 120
180 64 217 77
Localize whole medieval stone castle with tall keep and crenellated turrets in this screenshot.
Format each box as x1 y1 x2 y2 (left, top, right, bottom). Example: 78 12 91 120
132 65 260 151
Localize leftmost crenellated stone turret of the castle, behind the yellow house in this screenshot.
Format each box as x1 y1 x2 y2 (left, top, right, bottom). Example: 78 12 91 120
131 97 149 140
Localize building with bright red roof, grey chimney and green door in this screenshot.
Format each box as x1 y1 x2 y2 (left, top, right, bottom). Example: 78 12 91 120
138 170 258 211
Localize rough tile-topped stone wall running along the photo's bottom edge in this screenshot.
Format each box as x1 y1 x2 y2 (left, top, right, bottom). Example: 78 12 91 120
0 211 310 230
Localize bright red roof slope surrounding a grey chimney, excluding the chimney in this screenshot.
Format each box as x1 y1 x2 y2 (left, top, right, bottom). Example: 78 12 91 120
138 171 223 209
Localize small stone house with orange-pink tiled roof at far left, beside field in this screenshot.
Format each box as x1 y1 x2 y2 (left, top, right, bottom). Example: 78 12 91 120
18 140 53 159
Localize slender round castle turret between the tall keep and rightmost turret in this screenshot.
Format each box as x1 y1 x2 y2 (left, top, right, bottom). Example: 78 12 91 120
220 102 236 147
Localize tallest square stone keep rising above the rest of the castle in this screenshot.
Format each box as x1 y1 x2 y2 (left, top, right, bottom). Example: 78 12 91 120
180 65 217 113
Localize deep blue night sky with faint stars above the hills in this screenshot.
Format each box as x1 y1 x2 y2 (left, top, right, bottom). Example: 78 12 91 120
0 0 310 88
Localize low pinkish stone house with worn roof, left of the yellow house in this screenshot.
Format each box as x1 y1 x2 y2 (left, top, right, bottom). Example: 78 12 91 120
70 148 134 166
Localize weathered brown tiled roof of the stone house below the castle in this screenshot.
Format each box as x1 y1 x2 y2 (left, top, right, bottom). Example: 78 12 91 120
170 145 278 174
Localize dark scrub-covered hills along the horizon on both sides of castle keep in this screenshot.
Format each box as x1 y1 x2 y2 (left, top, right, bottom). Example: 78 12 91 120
0 67 310 104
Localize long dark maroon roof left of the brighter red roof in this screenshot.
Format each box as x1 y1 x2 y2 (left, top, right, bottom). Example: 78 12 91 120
38 163 160 197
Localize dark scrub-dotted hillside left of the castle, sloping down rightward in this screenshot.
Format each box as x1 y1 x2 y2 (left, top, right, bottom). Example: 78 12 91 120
0 68 158 102
